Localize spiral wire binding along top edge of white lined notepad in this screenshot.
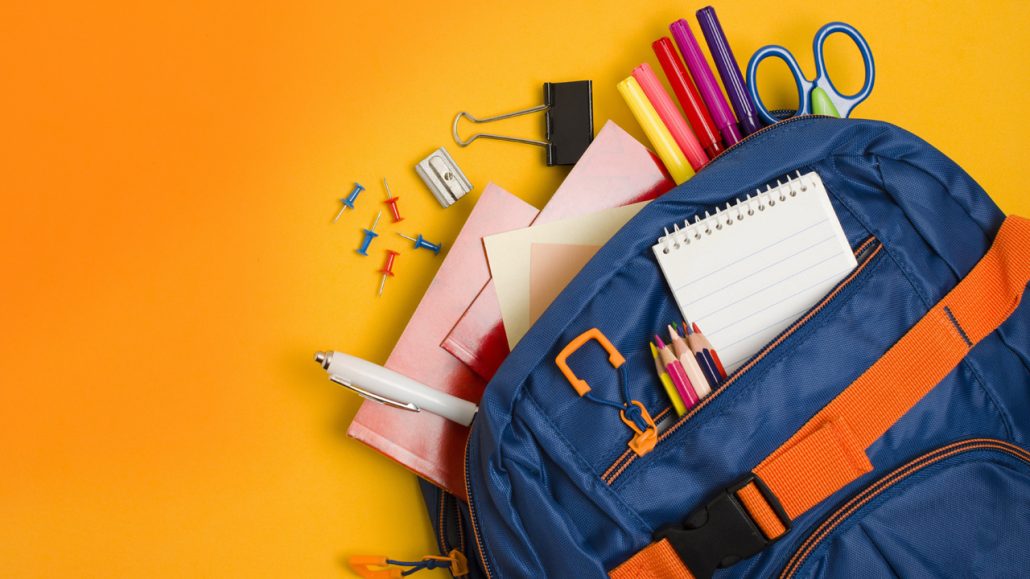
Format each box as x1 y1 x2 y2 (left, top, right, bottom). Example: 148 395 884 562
658 171 809 253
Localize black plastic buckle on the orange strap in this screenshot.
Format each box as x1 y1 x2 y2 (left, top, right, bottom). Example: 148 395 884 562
654 473 790 579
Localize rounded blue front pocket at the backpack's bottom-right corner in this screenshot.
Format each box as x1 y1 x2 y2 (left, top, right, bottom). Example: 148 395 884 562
780 439 1030 579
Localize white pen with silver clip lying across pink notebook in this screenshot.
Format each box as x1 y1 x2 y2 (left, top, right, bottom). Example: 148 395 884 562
315 351 479 427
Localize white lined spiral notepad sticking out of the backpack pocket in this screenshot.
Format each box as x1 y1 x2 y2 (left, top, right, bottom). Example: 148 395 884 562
654 172 857 372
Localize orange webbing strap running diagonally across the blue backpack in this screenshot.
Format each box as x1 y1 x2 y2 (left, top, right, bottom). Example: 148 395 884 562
609 216 1030 579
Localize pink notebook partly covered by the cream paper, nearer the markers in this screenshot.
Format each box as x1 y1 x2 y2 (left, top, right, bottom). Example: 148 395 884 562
441 121 676 380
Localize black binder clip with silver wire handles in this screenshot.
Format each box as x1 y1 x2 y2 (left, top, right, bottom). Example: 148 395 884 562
452 80 593 167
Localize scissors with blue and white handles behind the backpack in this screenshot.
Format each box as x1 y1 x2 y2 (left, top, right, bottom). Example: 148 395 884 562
748 22 877 124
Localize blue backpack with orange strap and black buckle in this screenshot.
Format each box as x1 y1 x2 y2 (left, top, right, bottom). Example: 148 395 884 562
397 116 1030 579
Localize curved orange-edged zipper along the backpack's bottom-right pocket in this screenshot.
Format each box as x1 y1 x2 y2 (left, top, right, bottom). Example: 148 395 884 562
780 438 1030 579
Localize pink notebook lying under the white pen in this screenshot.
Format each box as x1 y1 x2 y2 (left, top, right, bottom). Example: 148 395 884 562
347 183 537 498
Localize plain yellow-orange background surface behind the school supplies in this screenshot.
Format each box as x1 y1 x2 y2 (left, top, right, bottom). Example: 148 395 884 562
0 0 1030 577
